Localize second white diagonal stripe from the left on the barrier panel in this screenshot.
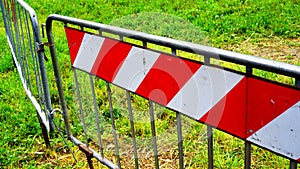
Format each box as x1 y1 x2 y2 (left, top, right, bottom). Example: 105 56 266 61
113 47 160 92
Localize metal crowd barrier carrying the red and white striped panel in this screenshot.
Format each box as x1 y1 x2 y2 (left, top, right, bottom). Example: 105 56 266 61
46 14 300 168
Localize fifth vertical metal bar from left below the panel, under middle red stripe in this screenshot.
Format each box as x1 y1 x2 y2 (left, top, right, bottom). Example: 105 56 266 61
149 100 159 169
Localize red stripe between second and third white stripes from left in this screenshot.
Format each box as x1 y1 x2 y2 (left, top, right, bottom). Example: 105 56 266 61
136 54 201 105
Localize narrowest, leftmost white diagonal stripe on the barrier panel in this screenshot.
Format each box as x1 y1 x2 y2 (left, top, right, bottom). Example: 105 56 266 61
73 33 104 72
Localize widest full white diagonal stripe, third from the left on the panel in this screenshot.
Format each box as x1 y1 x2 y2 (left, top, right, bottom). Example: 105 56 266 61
167 65 244 120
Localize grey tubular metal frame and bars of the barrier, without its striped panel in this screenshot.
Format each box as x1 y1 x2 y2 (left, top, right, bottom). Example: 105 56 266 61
46 14 300 169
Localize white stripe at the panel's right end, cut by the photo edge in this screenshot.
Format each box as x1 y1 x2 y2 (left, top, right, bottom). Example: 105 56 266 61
247 101 300 160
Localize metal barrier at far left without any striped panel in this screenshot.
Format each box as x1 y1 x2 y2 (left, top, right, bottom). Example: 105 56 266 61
0 0 53 146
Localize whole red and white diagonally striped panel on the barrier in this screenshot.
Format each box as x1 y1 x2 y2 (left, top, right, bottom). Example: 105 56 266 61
65 28 300 160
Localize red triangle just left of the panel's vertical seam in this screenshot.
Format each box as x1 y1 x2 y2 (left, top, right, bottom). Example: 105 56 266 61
200 78 247 139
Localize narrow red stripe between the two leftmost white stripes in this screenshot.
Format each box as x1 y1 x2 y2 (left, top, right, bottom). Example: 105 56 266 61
91 39 132 82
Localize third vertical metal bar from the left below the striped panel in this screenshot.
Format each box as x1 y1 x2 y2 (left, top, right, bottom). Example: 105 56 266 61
106 82 121 168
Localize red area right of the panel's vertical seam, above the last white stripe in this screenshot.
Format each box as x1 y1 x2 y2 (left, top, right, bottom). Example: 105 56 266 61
247 77 300 137
